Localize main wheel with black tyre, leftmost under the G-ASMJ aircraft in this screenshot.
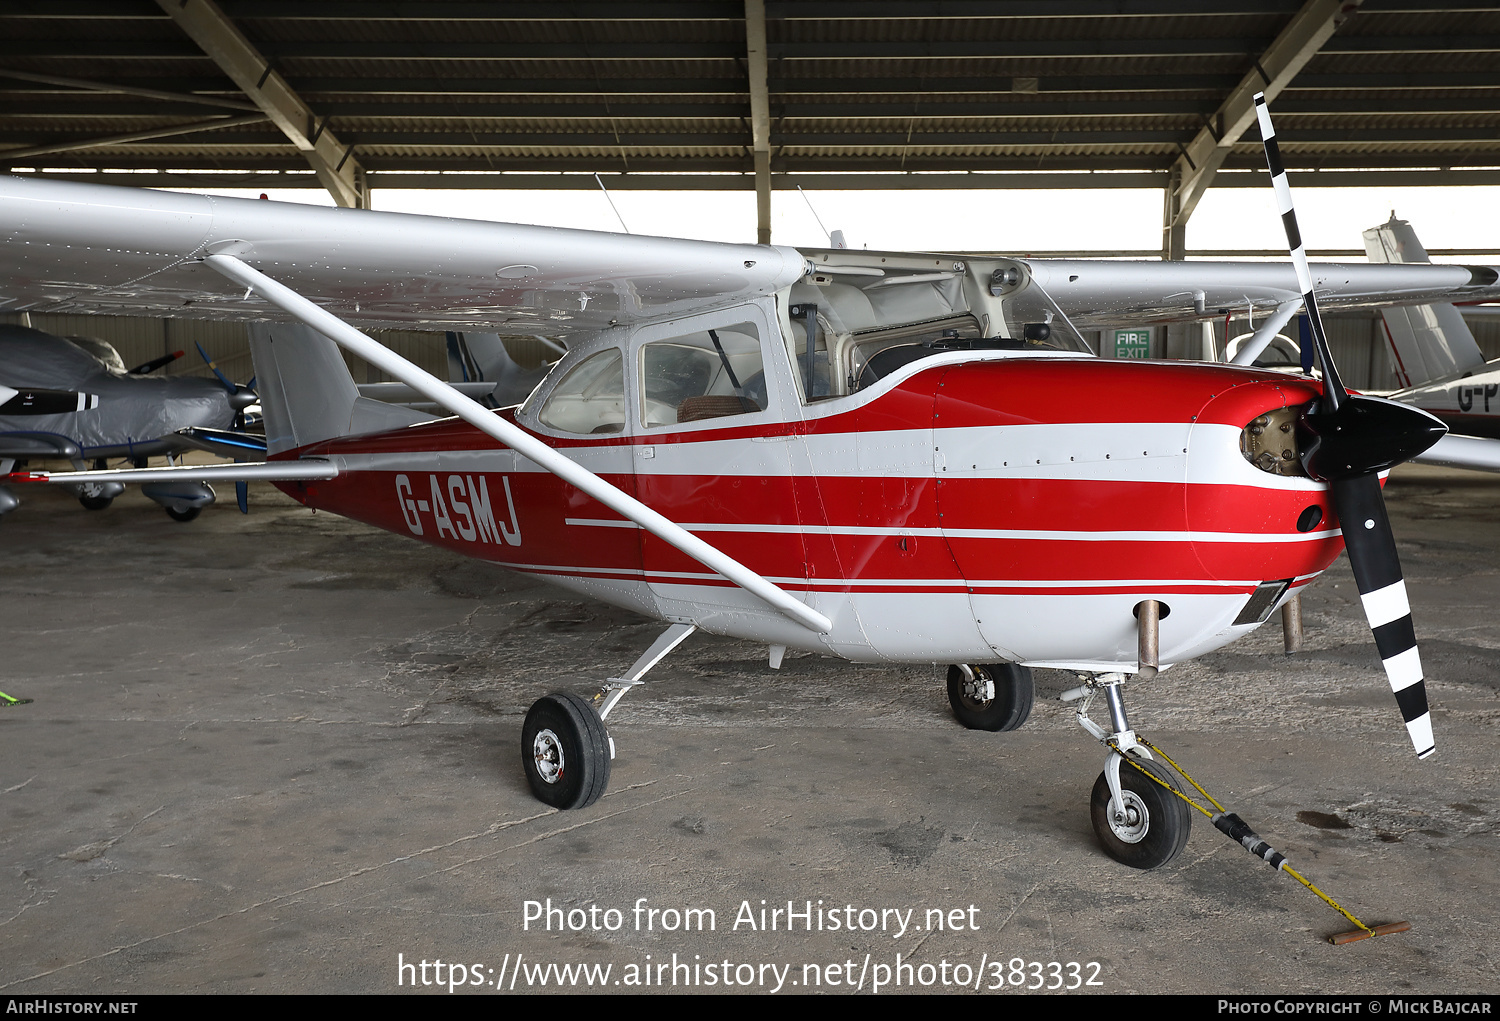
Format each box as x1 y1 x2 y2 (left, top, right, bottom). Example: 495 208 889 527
521 691 609 810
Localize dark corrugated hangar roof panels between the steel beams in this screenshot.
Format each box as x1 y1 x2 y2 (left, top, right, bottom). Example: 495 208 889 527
0 0 1500 189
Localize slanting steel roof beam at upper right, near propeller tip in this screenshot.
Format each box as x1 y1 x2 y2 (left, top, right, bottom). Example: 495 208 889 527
1161 0 1361 259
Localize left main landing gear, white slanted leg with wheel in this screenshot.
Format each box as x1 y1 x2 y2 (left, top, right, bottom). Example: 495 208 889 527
521 624 698 810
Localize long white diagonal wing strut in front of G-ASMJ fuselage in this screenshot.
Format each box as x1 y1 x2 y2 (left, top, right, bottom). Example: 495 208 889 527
204 252 833 634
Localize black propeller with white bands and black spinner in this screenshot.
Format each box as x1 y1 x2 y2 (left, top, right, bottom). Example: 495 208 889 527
1256 94 1448 759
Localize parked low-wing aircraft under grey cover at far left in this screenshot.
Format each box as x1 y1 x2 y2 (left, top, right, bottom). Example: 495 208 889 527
0 325 255 522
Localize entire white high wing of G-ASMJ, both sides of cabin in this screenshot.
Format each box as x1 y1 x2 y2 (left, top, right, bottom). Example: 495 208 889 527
0 175 1500 336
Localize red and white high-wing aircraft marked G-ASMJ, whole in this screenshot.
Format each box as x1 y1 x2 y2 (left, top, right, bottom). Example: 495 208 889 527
0 99 1500 868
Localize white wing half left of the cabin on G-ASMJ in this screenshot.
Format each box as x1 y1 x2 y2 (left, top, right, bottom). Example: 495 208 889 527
0 175 804 329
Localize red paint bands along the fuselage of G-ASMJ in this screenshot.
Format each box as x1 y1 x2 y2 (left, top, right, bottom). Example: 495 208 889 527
282 358 1341 592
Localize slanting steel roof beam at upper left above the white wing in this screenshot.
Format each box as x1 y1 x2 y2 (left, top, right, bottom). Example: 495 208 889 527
156 0 369 208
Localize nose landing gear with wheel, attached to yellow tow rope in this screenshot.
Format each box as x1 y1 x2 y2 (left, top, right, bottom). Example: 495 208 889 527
1064 673 1193 868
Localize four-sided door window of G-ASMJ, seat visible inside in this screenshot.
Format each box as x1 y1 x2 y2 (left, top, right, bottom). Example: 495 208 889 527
641 322 767 429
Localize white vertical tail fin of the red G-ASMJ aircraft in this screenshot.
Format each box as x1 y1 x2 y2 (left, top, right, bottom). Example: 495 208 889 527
251 322 434 454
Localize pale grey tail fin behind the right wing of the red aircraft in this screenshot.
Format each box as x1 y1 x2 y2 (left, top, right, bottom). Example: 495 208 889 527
1364 211 1485 387
